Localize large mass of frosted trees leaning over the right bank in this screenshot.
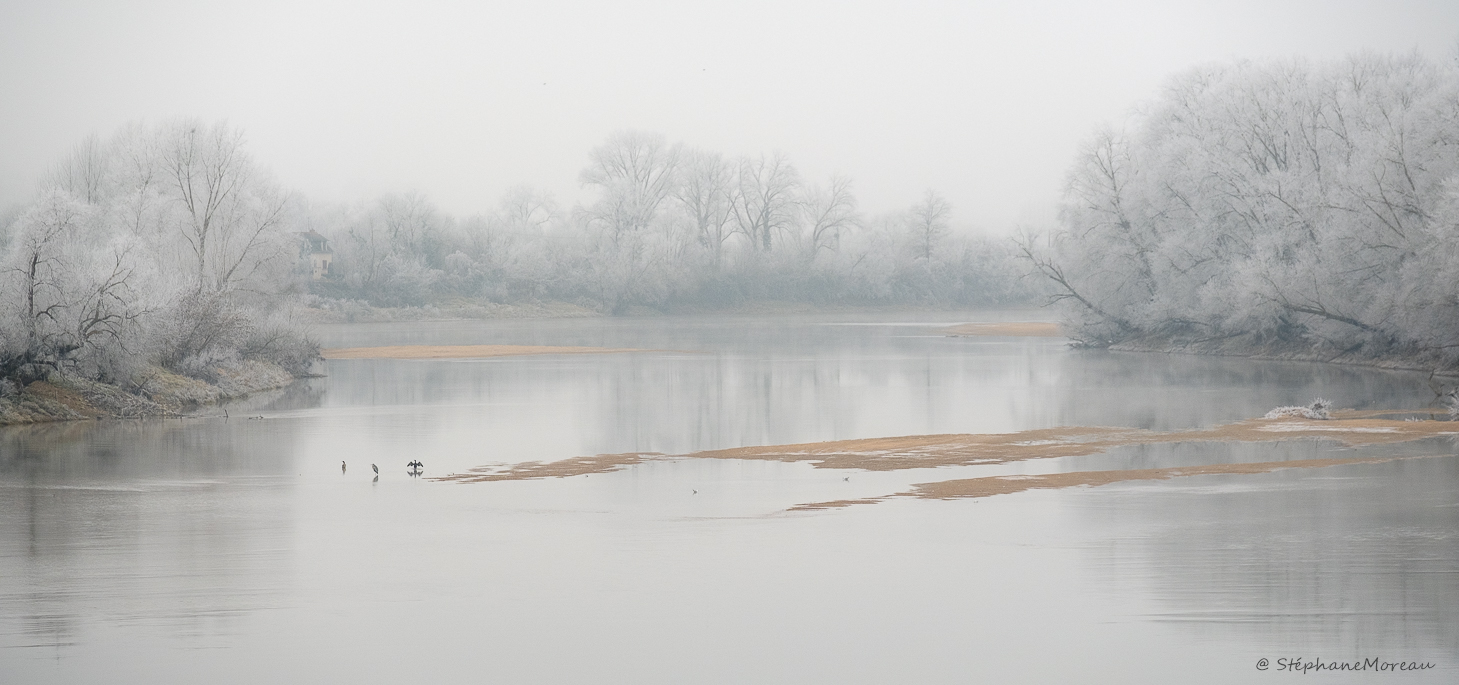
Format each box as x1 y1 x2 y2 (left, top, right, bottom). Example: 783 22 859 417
1021 54 1459 365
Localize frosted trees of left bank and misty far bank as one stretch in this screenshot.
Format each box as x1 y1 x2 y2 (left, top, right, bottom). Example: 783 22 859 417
0 120 1029 391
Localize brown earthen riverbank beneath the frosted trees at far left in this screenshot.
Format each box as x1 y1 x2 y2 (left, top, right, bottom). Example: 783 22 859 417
0 361 296 425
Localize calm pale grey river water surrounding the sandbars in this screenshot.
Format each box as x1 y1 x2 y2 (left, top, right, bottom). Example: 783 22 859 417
0 313 1459 684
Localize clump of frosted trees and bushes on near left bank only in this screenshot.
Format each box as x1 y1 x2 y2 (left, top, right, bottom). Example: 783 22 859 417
0 121 308 384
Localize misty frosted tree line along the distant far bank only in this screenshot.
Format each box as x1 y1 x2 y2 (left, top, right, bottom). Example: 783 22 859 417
309 131 1030 314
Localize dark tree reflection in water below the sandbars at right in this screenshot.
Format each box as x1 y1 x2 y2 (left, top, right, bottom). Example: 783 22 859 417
1072 444 1459 659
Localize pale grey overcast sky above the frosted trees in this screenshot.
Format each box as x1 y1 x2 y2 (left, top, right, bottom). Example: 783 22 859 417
0 0 1459 234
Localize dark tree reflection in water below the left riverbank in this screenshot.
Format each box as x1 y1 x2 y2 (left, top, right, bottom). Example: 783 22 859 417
0 419 295 647
